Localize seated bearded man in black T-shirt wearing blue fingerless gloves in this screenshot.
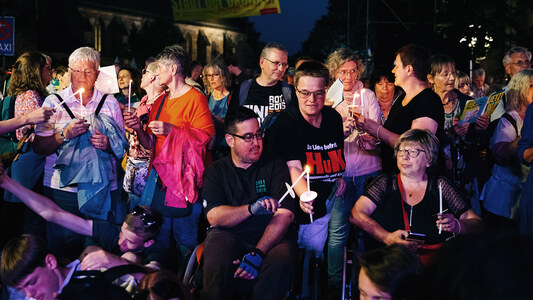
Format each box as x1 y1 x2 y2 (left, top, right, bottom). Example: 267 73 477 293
202 106 298 299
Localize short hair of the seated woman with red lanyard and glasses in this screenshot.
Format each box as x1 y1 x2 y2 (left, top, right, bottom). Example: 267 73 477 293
394 129 439 165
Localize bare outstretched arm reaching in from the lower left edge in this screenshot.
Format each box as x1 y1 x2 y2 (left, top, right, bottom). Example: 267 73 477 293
0 171 93 236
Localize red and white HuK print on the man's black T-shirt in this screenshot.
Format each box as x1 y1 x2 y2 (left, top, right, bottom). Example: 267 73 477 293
305 143 346 182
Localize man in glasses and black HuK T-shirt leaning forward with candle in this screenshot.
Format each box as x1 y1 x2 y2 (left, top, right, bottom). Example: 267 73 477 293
268 61 346 264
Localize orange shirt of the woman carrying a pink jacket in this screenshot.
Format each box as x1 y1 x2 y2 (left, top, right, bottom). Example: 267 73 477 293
147 88 215 156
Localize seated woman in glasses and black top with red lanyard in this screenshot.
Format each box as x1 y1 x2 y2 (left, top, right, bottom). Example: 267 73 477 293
350 129 483 262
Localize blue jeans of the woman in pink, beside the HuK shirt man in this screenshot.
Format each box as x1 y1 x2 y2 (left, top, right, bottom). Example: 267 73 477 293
328 171 381 284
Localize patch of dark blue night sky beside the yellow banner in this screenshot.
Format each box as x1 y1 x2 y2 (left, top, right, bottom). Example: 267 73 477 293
250 0 328 55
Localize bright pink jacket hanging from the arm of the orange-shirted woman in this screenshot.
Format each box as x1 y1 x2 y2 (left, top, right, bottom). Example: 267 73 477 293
153 126 210 208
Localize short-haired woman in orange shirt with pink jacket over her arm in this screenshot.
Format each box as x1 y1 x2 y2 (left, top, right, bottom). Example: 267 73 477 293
124 45 215 257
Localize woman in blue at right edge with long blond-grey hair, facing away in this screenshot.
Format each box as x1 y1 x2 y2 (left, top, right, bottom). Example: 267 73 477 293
481 70 533 230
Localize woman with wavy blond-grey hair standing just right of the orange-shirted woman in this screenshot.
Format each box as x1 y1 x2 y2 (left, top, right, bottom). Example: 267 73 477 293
203 59 231 159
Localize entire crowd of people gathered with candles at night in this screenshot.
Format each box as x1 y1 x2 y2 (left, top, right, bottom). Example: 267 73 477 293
0 43 533 300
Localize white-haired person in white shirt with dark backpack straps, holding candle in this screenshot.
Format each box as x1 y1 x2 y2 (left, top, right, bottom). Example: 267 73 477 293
34 47 126 258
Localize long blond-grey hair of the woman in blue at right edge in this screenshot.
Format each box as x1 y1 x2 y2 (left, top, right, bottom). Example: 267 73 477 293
504 70 533 111
